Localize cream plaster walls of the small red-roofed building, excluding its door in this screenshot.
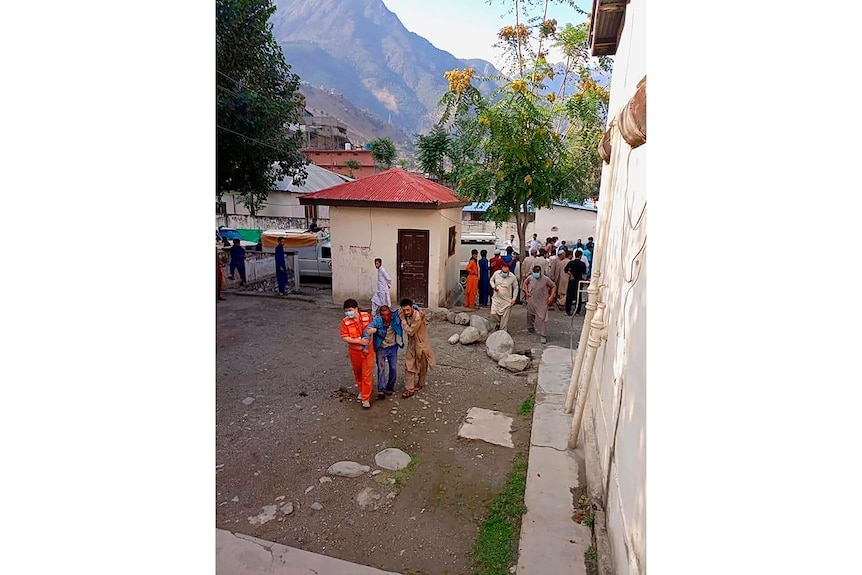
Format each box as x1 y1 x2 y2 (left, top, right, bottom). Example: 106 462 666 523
329 207 461 306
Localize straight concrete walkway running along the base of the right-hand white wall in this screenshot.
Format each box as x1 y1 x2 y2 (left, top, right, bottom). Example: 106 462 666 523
517 346 592 575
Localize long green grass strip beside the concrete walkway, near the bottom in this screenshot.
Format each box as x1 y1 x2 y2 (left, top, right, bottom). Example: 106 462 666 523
472 453 527 575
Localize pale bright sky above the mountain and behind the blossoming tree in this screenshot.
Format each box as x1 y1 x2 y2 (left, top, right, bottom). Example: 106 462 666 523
383 0 592 67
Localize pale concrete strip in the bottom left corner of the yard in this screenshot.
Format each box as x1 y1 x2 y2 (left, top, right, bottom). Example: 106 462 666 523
216 529 398 575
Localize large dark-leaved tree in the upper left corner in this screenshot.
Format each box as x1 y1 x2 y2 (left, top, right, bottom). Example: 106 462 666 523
216 0 307 214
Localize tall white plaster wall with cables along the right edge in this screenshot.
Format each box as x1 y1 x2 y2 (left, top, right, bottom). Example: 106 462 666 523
589 0 647 575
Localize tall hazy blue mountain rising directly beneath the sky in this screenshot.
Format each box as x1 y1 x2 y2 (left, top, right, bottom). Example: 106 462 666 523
271 0 500 135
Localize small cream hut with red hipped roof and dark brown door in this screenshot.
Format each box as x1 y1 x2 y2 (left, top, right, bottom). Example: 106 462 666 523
299 168 470 307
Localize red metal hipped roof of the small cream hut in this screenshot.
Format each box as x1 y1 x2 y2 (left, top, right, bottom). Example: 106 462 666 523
300 168 470 209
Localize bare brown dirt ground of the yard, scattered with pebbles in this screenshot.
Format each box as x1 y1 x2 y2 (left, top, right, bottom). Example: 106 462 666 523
216 289 582 575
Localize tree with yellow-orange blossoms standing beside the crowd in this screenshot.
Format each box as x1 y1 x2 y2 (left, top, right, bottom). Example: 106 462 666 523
438 0 610 254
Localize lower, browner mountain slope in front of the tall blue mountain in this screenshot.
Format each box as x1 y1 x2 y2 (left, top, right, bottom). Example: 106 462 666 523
299 84 413 150
